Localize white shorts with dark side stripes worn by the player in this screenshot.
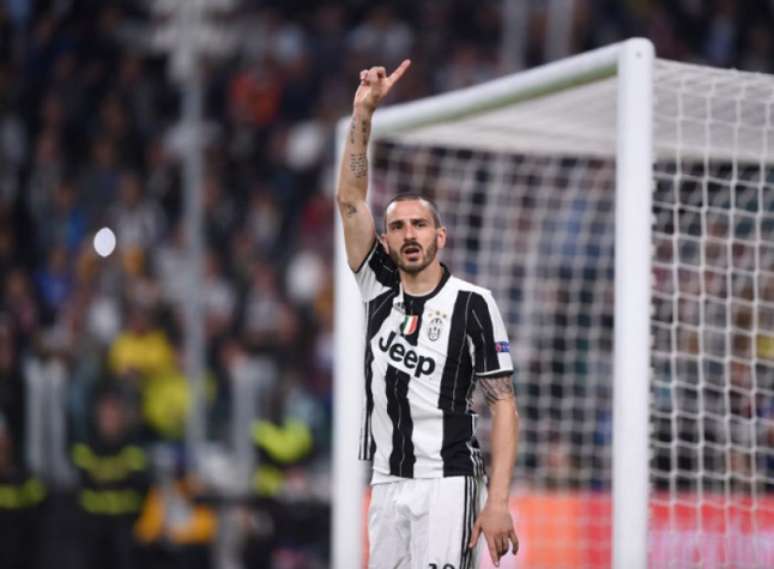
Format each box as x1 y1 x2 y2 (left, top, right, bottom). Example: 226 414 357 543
368 476 486 569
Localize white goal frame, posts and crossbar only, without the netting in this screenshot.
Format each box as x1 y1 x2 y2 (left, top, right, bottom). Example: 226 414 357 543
331 38 655 569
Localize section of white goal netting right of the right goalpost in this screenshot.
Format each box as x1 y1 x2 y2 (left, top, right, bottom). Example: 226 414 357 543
651 58 774 568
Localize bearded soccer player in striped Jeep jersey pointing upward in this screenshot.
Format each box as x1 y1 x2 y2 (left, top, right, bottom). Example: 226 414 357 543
336 60 519 569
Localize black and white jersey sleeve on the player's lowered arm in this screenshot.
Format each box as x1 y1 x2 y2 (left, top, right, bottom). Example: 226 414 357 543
468 291 513 377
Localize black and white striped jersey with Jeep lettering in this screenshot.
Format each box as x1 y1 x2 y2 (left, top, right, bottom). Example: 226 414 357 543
355 242 513 482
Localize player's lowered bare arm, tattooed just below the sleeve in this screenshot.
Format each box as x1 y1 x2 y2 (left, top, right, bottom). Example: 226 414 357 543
470 374 519 567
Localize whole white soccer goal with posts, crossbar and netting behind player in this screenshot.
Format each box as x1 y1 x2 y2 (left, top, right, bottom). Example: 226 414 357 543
331 39 774 569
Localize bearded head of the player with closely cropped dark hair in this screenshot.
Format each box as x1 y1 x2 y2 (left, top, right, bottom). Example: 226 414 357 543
382 200 446 274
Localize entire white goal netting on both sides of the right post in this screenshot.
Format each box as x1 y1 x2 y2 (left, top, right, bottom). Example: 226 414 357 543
371 56 774 569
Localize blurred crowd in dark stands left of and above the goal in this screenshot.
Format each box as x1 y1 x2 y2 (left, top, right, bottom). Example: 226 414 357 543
0 0 774 568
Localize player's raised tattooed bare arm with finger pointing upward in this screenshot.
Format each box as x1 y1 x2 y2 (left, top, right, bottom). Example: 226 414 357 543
336 59 411 270
